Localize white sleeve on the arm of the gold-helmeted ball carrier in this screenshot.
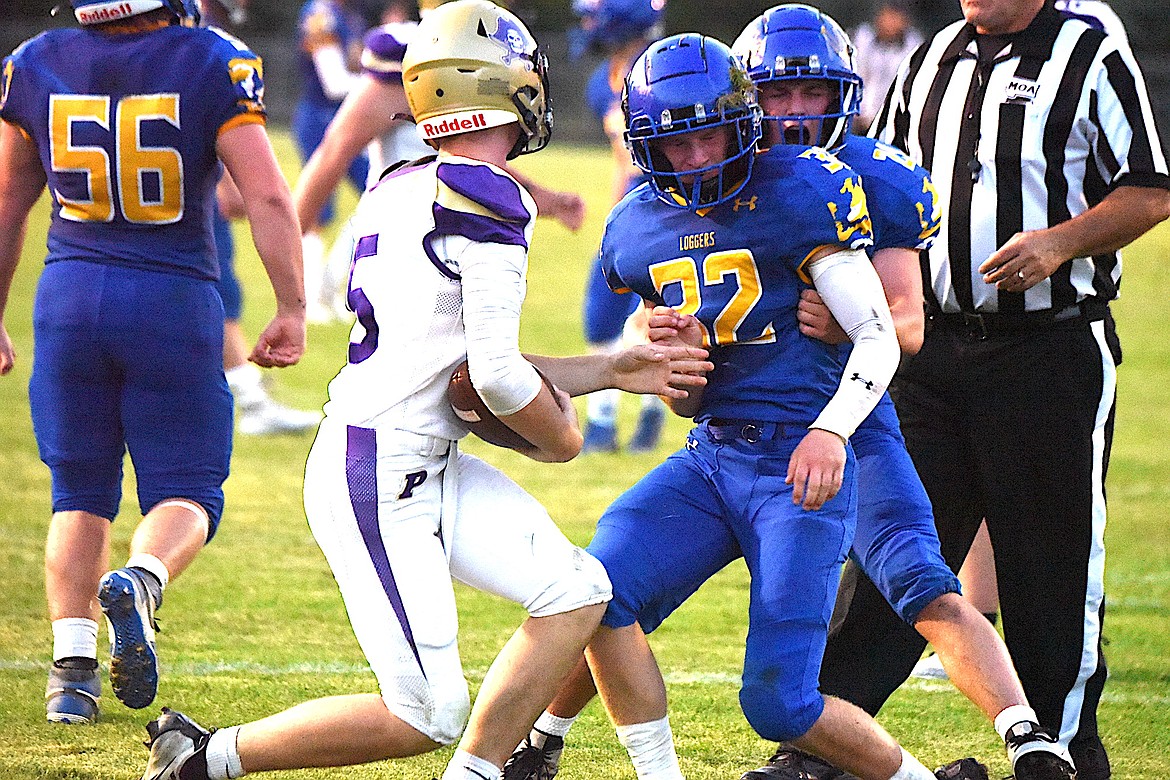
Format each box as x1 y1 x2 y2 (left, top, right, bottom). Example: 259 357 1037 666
458 237 543 417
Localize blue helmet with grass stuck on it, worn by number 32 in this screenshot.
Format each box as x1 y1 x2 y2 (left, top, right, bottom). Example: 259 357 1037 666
621 33 763 209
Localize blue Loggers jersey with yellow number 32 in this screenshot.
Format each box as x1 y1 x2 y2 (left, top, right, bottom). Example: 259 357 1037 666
601 146 872 426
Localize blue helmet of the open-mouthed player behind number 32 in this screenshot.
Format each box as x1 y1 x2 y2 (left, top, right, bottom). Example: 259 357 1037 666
731 4 862 150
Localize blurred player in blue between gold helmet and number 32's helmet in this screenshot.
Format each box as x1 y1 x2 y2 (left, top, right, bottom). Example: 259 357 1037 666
570 0 666 453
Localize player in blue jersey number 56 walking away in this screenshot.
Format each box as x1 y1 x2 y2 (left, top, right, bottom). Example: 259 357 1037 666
0 0 304 723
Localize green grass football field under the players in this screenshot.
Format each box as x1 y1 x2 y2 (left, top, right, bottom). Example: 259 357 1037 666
0 136 1170 780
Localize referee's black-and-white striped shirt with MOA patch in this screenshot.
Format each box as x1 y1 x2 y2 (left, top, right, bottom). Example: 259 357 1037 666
872 1 1170 313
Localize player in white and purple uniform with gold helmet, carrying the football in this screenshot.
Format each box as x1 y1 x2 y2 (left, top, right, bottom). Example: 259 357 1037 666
132 0 711 780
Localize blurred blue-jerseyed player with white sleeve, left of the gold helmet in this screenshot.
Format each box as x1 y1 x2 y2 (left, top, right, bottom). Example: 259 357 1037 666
293 0 370 323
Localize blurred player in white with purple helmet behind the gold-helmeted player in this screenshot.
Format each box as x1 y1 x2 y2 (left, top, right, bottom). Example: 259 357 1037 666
295 0 585 320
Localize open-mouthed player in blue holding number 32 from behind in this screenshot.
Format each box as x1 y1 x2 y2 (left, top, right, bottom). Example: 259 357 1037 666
732 4 1072 780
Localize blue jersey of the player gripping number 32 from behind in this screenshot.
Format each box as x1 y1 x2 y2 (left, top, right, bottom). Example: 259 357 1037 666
834 136 942 432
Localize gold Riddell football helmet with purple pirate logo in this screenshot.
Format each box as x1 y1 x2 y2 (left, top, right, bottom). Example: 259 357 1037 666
402 0 552 159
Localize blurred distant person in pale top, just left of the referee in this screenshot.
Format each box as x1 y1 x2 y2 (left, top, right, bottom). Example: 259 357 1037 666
853 0 923 133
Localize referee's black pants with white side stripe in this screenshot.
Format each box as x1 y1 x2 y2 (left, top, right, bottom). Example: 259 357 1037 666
821 317 1120 780
